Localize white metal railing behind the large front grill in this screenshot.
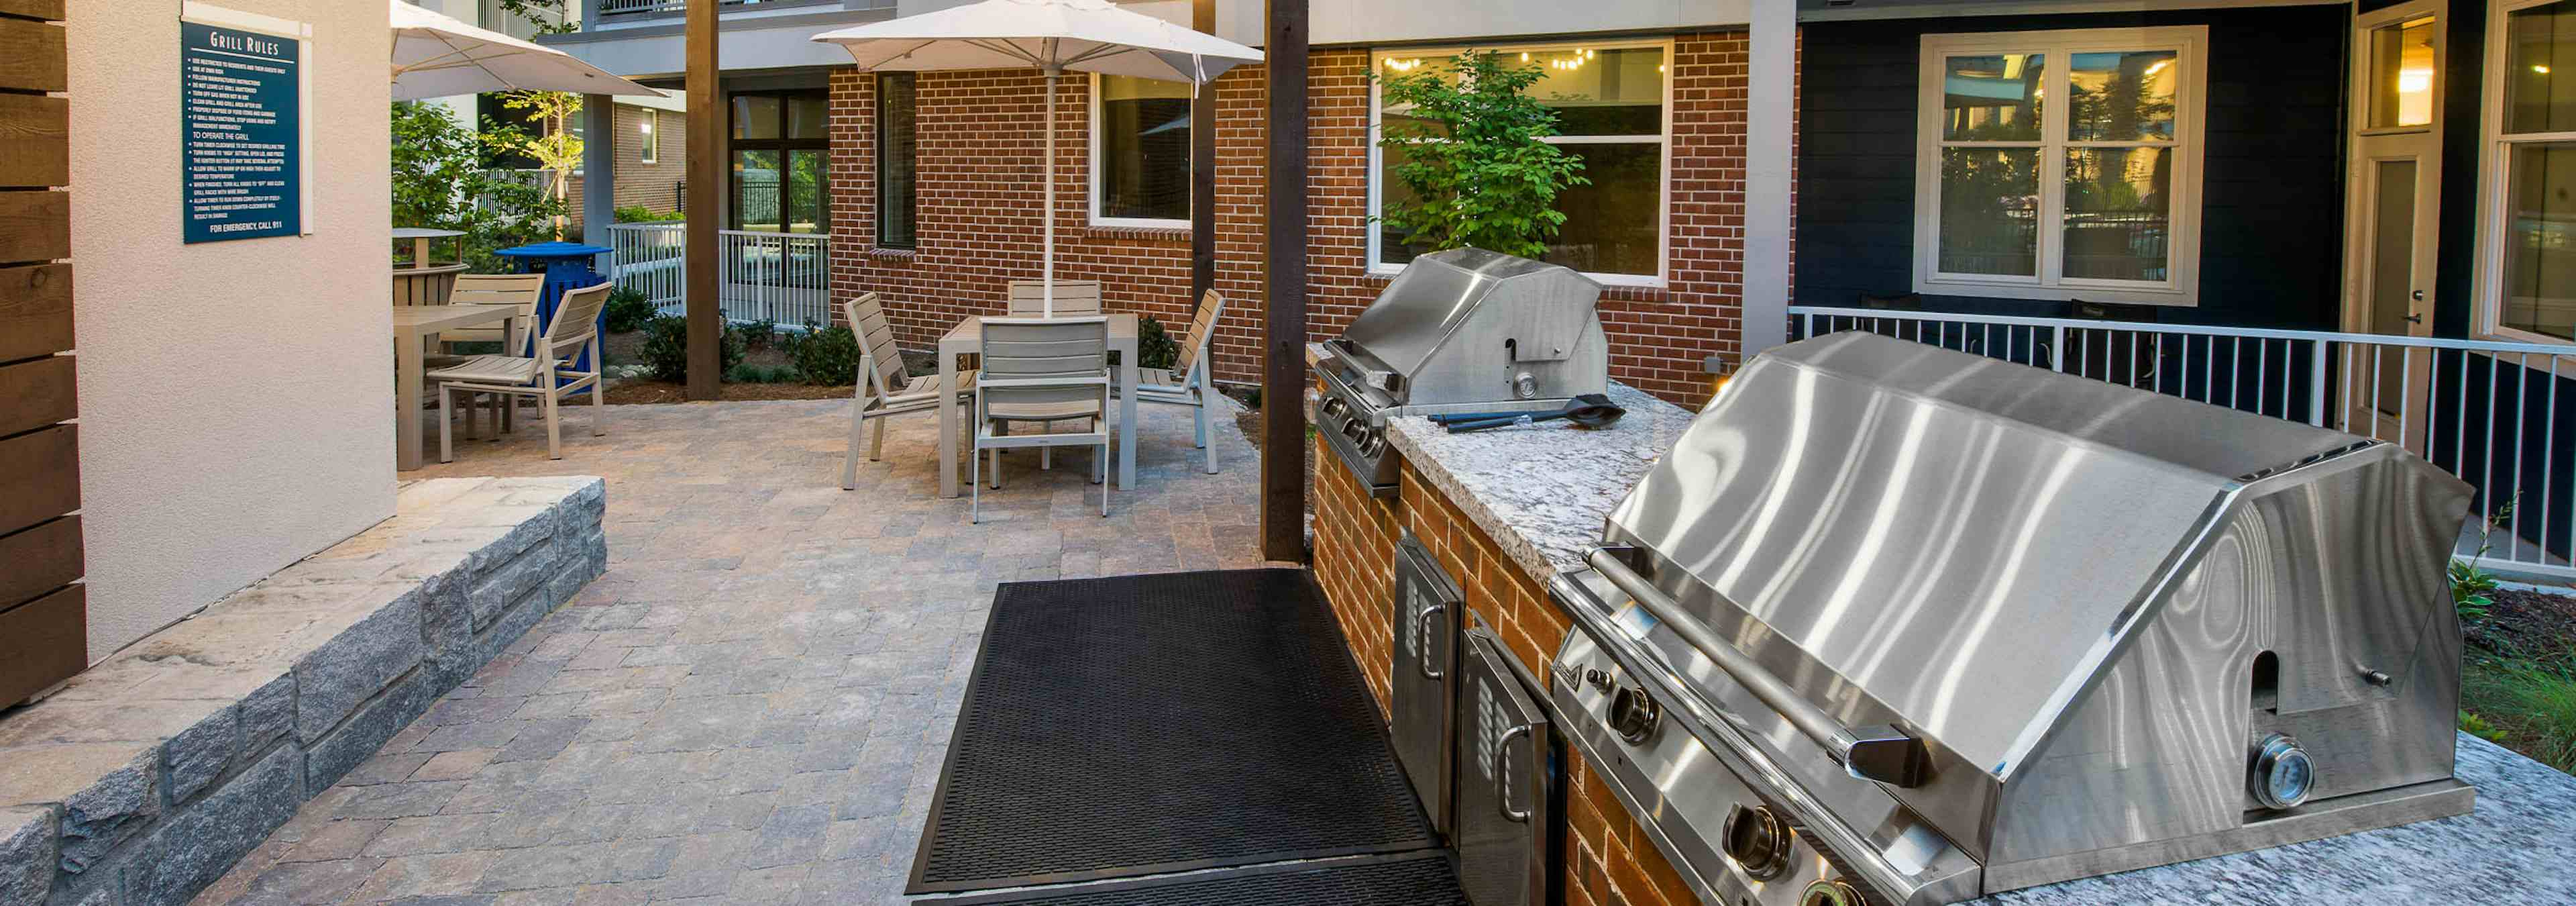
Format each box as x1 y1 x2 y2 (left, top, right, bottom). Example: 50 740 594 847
1788 306 2576 576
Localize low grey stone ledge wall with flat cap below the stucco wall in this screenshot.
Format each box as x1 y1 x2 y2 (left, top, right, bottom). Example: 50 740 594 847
0 476 608 906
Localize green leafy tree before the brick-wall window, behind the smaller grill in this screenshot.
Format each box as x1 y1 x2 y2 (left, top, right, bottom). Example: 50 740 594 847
1378 52 1589 258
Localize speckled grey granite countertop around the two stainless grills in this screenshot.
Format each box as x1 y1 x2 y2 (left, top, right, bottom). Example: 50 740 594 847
1389 381 2576 906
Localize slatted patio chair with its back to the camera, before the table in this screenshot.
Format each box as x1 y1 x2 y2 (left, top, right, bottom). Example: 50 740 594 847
966 314 1110 523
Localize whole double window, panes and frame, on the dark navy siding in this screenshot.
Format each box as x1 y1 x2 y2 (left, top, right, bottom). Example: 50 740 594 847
1914 26 2208 306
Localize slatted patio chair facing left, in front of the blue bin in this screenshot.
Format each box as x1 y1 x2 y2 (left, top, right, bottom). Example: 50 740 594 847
427 283 610 463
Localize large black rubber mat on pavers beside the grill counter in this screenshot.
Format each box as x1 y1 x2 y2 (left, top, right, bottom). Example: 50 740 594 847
907 569 1432 893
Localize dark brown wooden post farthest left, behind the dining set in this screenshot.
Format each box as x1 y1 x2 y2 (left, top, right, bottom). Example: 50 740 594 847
683 0 727 399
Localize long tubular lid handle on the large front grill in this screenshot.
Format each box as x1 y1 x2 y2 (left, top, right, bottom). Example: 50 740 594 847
1585 548 1932 788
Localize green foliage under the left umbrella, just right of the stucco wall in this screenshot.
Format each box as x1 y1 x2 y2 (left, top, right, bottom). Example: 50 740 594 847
392 101 564 273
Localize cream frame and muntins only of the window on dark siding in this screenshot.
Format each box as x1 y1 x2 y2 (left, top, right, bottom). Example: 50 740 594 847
1911 26 2210 309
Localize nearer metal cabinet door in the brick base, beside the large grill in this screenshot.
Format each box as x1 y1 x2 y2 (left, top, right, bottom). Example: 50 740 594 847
1453 628 1556 906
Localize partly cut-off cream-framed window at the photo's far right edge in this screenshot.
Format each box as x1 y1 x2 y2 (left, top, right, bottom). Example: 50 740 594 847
2473 0 2576 342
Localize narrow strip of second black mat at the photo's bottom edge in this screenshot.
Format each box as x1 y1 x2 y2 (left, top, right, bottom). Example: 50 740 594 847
958 852 1468 906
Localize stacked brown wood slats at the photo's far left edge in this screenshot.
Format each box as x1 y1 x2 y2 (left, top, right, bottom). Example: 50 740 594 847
0 0 90 708
